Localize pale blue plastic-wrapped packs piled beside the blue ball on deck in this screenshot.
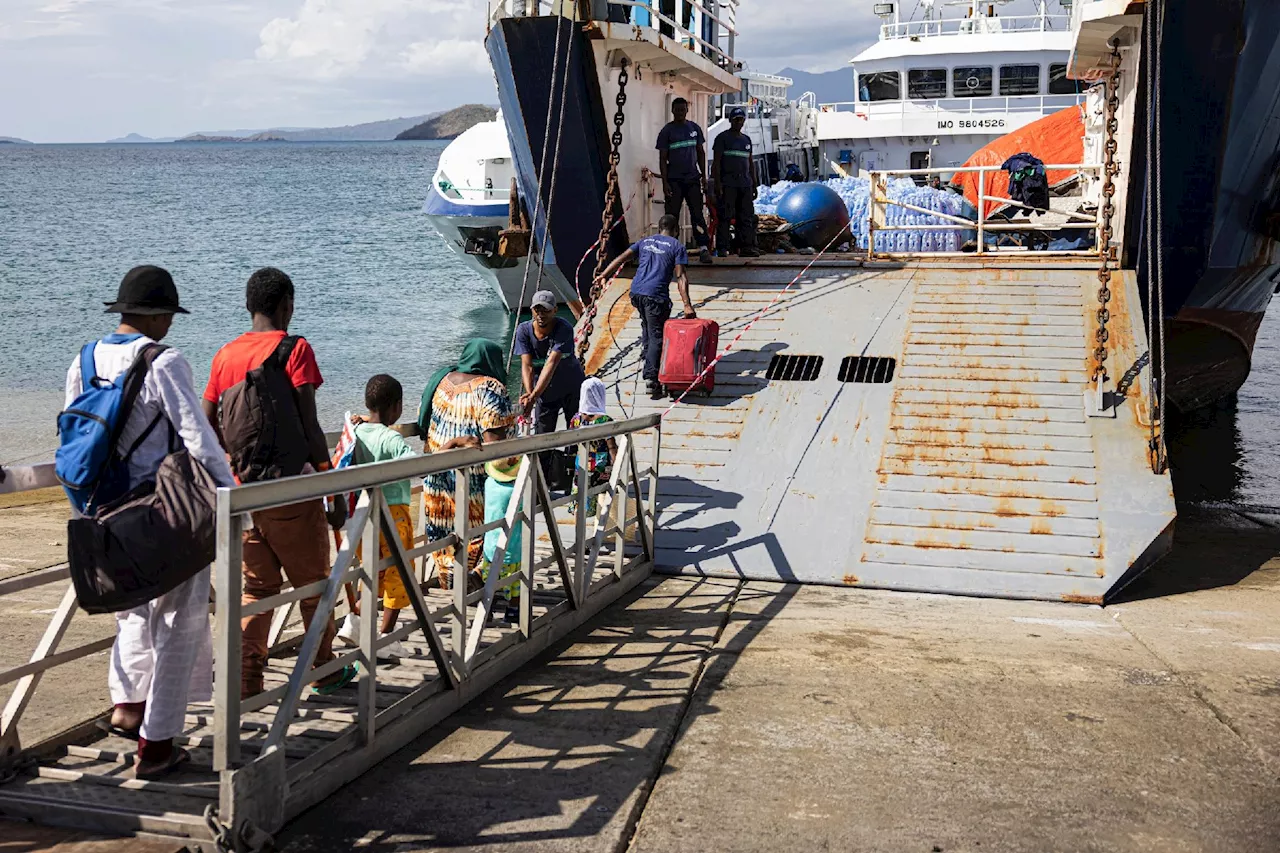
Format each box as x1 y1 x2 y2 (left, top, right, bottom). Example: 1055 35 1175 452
755 178 978 252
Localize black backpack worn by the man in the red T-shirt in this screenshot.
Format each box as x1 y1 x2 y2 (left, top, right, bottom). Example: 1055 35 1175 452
219 334 310 483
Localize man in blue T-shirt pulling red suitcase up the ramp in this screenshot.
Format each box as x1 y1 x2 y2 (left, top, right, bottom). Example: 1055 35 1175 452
596 214 698 400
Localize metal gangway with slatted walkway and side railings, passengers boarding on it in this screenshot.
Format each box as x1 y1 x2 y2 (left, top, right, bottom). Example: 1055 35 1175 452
0 415 662 850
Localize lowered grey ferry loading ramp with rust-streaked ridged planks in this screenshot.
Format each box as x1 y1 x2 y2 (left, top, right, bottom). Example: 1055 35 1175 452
588 255 1174 603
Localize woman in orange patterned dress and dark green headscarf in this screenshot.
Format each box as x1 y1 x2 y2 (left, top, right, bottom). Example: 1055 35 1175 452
417 338 516 589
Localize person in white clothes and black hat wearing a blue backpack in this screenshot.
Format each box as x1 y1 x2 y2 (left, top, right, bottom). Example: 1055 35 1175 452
67 266 236 779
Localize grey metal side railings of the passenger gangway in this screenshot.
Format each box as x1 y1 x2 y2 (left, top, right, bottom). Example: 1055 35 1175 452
0 414 662 827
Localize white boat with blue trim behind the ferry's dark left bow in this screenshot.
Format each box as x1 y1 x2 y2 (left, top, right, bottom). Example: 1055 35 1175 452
422 113 571 310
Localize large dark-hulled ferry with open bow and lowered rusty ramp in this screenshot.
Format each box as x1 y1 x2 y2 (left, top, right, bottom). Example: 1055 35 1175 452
486 0 1280 602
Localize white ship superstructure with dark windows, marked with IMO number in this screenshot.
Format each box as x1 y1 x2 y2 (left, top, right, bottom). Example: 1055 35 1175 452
818 0 1084 174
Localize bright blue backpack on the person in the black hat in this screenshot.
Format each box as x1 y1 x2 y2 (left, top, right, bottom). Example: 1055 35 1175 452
54 341 169 515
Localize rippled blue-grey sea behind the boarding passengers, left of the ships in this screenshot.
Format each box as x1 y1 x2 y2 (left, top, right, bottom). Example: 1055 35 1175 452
0 142 511 464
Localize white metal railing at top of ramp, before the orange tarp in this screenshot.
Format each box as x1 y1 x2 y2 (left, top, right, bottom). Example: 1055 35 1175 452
867 163 1103 257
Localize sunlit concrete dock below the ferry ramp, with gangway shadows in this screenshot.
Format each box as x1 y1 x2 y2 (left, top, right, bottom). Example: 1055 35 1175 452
0 489 1280 853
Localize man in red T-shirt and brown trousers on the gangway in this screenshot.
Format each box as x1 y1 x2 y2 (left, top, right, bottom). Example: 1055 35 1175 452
201 266 356 698
